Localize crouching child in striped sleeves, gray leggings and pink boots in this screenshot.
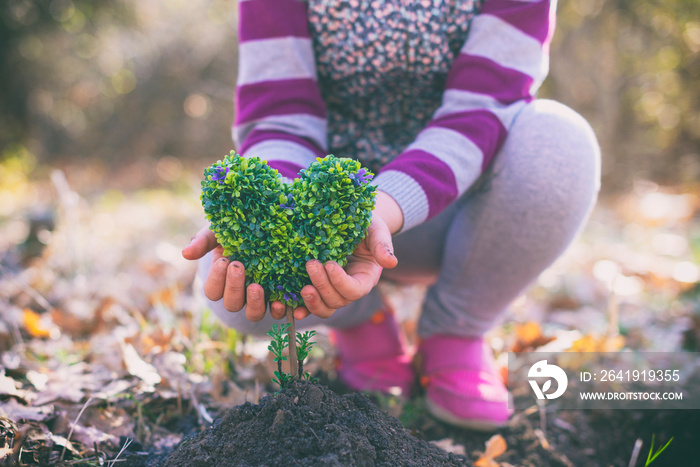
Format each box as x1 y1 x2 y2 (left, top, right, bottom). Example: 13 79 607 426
183 0 599 430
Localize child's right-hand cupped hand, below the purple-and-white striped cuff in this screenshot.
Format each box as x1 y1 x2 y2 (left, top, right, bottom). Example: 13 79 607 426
295 191 403 318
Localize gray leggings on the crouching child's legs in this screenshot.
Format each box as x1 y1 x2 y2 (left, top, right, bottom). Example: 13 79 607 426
199 100 600 338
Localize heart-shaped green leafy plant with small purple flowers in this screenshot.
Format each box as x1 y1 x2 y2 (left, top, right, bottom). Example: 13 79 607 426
201 151 376 308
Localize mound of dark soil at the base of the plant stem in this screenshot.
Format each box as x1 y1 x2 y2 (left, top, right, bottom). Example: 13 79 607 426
163 381 471 467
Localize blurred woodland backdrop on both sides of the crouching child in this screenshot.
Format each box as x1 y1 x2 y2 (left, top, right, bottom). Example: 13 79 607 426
0 0 700 192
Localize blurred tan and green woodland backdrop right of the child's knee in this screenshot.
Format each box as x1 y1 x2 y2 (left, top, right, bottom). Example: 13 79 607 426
545 0 700 191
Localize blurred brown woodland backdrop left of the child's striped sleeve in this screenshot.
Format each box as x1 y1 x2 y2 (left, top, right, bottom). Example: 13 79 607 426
0 0 236 188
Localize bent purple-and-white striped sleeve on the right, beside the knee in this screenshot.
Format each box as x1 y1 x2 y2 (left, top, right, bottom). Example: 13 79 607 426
373 0 556 230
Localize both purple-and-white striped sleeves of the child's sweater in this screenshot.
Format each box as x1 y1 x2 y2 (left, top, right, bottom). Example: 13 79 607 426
233 0 556 230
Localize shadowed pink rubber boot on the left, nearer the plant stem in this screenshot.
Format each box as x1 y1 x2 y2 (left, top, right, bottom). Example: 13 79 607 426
331 309 414 396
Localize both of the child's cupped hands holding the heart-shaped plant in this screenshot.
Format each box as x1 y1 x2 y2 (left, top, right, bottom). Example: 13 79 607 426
182 191 403 321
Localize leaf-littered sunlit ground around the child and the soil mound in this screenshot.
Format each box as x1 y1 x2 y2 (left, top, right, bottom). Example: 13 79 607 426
0 159 700 467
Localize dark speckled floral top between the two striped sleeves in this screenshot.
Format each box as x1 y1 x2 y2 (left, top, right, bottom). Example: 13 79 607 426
308 0 479 172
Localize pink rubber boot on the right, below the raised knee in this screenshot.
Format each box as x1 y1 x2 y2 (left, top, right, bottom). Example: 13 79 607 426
418 335 512 431
